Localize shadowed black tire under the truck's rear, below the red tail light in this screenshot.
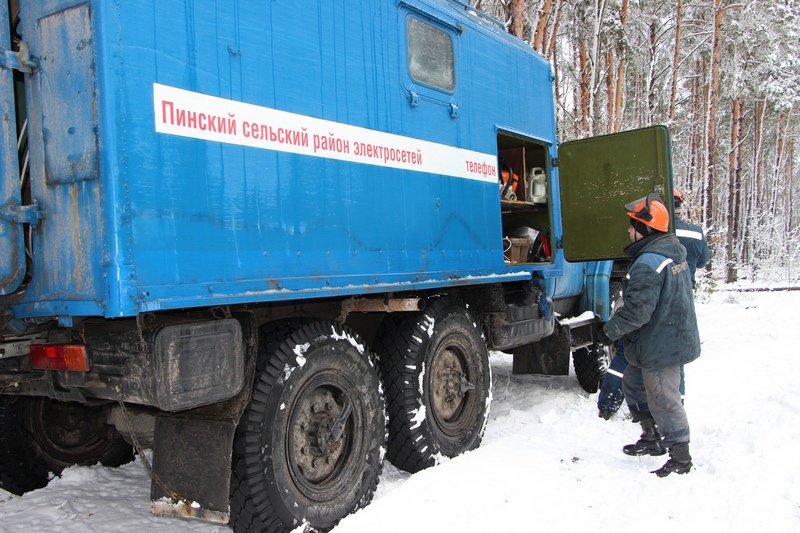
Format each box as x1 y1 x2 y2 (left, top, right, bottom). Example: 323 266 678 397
0 397 134 494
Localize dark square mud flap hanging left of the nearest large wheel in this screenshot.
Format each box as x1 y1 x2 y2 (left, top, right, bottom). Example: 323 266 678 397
150 415 236 524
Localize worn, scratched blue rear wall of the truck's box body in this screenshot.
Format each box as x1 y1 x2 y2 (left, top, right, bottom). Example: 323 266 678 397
8 1 110 323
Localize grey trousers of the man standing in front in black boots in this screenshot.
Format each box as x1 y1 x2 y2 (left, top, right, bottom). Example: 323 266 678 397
622 365 689 448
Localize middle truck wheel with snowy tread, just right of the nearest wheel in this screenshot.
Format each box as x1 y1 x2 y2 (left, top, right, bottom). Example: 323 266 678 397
376 297 492 472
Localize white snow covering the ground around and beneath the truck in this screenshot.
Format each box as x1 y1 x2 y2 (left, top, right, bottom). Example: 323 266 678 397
0 291 800 533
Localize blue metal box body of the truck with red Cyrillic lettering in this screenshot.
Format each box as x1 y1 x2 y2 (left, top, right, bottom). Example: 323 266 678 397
4 0 580 317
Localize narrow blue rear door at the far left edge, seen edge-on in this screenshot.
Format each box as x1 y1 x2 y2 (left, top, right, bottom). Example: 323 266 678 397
0 2 25 295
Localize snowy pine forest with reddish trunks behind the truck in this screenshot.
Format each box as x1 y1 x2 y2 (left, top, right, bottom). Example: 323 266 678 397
470 0 800 283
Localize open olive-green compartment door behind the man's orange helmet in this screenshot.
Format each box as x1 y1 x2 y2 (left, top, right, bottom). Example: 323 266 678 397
558 126 675 261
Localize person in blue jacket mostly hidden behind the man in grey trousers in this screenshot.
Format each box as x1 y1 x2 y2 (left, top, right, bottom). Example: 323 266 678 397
597 189 710 420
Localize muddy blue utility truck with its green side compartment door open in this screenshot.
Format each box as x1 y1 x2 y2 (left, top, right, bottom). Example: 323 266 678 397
0 0 672 531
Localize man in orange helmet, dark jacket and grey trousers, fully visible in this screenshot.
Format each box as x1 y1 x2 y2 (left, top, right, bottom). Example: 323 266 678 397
598 194 700 477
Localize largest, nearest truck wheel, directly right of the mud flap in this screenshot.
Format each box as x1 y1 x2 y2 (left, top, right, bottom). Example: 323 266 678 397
230 321 386 532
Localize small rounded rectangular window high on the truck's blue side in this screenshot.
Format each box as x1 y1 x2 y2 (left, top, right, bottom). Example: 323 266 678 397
407 17 456 92
